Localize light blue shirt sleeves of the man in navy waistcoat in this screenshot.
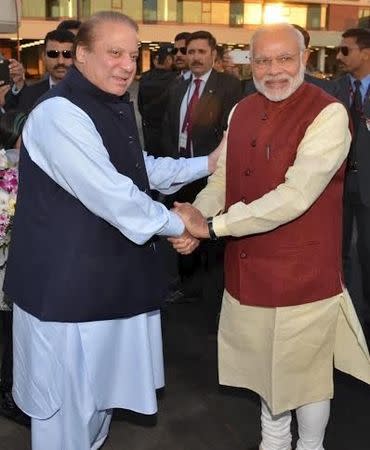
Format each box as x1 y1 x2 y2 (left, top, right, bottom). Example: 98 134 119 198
22 97 209 244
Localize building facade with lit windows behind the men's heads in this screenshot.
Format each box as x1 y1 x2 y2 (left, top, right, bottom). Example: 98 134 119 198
0 0 370 75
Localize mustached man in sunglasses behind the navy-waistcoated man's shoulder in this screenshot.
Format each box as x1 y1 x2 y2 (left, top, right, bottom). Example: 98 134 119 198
7 29 74 113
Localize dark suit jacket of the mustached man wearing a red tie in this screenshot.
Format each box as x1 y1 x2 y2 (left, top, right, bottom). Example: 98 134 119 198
162 69 242 201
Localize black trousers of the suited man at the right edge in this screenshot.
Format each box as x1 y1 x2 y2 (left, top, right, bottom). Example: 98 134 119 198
343 172 370 325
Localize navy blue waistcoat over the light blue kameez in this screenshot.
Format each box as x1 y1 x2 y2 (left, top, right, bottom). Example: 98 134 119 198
4 67 166 322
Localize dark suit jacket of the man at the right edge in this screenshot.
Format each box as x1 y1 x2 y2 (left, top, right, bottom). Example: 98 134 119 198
335 75 370 206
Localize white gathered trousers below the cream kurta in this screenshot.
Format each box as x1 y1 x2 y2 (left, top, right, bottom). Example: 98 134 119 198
260 399 330 450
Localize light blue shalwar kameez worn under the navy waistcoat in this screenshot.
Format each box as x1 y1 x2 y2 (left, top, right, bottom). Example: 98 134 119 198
13 97 208 450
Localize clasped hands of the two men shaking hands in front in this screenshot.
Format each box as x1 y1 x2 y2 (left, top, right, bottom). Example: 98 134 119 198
168 202 210 255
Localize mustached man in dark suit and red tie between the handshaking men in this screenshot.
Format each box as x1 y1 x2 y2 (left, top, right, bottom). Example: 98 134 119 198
162 31 241 310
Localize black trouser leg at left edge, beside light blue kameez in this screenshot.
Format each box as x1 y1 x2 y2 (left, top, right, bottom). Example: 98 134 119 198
0 311 13 392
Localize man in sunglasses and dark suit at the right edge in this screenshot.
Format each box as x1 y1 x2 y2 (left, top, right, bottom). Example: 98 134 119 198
336 28 370 342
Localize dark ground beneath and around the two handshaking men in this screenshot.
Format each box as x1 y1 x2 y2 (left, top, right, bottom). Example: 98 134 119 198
0 303 370 450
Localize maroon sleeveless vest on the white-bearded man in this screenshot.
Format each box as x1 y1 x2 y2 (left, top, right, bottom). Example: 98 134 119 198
225 83 344 307
